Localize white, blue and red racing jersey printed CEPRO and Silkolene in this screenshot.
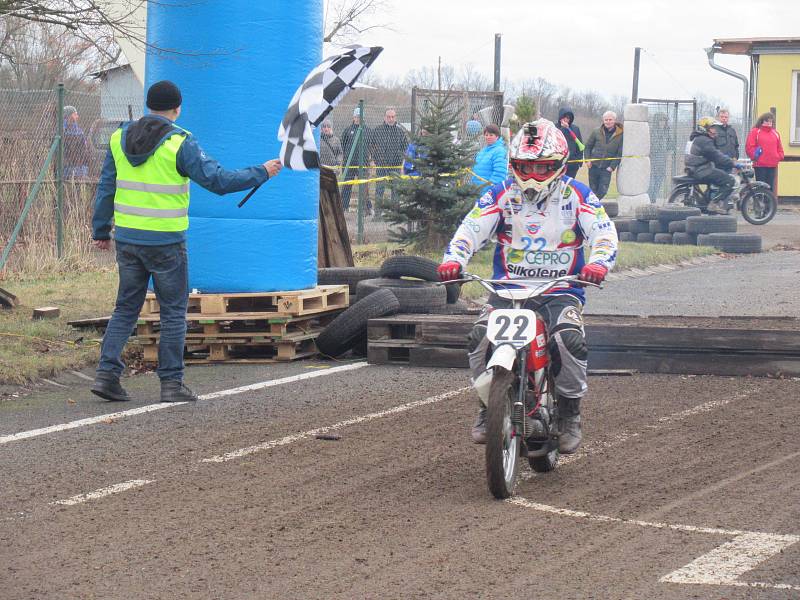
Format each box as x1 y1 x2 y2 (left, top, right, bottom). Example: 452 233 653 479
444 176 618 302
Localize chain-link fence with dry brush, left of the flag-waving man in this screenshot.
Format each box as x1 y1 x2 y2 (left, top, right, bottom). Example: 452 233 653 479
0 90 143 270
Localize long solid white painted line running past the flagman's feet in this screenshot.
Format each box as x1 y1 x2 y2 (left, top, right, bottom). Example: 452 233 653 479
0 362 369 446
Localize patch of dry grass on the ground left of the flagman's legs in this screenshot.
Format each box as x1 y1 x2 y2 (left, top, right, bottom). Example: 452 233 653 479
0 269 117 384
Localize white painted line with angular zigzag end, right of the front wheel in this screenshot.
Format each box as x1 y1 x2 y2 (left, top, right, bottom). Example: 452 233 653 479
506 496 800 591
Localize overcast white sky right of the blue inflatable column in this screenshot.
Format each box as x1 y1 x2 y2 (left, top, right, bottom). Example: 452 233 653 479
346 0 800 118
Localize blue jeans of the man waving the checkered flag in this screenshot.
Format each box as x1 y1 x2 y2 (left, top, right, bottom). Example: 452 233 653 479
97 242 189 381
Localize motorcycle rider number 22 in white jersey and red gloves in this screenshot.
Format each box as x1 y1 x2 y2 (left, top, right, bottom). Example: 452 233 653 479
438 119 617 454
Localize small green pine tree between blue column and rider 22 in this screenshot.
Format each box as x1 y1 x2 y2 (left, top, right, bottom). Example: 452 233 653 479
382 92 480 251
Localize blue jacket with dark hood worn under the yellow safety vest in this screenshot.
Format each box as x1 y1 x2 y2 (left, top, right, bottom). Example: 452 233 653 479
92 115 269 246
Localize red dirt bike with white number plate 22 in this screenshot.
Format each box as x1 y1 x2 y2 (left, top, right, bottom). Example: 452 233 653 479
448 273 600 498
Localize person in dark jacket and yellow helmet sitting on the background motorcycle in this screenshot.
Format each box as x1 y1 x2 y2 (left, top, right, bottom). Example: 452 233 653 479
685 117 737 214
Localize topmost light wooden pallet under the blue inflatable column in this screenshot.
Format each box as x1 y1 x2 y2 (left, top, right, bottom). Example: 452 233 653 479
140 285 350 320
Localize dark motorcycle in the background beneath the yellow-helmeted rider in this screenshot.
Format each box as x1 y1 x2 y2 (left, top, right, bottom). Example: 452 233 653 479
667 162 778 225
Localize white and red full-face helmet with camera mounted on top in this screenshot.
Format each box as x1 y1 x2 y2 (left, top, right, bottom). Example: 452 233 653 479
509 119 569 200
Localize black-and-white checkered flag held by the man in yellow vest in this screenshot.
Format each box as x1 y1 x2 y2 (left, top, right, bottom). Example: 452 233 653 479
278 46 383 171
